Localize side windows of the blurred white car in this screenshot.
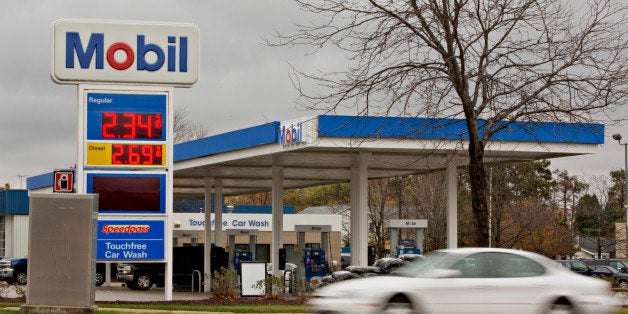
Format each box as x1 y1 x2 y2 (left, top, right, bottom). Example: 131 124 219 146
452 252 545 278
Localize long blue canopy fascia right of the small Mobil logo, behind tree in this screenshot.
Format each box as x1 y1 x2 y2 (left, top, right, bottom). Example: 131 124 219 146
318 115 604 144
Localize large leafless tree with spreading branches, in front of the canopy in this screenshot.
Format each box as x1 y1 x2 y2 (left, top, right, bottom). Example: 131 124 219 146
271 0 628 246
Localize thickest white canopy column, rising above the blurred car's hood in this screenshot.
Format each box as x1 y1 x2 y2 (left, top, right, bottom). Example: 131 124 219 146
351 153 370 266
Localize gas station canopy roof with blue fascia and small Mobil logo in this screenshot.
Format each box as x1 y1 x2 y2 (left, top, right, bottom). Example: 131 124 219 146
174 115 604 198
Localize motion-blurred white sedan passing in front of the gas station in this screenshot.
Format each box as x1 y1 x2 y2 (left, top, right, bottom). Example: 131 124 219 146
309 248 618 314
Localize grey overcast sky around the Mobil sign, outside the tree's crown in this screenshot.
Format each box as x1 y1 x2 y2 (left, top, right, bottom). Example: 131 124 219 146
0 0 628 183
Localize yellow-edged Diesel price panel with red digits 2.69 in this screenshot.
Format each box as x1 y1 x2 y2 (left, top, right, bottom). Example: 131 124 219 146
85 142 166 167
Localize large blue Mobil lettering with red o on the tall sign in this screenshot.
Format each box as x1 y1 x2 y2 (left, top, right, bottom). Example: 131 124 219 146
65 32 188 72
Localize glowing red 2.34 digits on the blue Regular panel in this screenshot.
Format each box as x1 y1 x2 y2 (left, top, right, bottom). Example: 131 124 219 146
101 112 164 139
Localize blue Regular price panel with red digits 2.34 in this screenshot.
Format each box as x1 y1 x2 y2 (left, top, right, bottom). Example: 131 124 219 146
85 92 167 141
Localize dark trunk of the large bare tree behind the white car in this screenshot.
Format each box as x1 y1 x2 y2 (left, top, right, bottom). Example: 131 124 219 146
469 128 488 247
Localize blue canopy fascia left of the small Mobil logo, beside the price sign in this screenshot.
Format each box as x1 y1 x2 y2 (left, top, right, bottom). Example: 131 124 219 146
173 122 279 162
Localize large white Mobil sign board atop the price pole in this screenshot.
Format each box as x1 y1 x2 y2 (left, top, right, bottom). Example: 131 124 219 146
52 19 200 87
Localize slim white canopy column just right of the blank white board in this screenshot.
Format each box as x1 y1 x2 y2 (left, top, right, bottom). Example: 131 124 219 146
271 166 284 274
